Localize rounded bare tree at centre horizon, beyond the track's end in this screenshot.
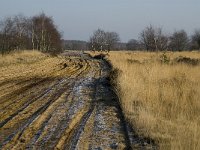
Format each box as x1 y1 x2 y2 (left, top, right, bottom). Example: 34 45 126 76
89 29 120 51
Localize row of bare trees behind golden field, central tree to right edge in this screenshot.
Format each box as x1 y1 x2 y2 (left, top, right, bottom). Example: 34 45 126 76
89 25 200 51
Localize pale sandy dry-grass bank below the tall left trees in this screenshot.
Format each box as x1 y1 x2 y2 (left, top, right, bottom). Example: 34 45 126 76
0 50 77 82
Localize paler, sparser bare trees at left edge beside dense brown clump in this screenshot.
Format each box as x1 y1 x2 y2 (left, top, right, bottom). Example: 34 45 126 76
0 15 31 53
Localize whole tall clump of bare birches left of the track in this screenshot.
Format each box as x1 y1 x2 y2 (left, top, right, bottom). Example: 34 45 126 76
0 13 62 54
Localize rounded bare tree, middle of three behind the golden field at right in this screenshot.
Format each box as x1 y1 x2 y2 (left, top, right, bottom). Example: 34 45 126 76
169 30 189 51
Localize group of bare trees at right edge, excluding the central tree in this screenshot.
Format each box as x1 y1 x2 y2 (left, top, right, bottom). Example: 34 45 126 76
138 25 200 51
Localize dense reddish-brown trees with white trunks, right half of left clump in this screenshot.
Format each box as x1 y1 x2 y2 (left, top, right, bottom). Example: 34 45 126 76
30 13 62 53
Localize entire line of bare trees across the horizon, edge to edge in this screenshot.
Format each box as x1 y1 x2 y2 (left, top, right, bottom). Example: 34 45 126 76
0 13 200 54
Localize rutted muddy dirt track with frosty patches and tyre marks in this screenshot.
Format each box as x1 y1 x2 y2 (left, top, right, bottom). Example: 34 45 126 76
0 52 155 150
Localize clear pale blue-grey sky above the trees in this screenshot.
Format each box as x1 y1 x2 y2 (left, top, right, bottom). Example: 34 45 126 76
0 0 200 42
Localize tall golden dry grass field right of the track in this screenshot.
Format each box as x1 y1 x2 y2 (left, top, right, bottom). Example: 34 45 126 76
109 52 200 150
